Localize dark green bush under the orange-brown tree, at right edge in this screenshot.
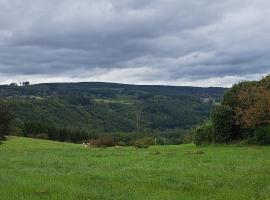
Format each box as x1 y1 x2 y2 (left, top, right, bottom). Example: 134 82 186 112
253 125 270 145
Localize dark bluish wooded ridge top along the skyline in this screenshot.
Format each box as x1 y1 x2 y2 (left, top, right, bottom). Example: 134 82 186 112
0 82 225 98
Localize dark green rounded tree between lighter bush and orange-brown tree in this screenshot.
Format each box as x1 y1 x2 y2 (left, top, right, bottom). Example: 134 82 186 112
211 105 233 143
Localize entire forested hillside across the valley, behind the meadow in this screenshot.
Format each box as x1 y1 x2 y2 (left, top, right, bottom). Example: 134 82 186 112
0 83 225 144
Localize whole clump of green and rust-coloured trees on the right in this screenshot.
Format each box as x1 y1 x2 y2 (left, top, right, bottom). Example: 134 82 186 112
194 76 270 145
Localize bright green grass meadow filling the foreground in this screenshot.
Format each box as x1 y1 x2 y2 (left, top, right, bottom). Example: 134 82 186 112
0 137 270 200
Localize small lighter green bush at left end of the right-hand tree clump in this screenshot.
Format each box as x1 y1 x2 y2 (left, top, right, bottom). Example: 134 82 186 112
193 121 215 145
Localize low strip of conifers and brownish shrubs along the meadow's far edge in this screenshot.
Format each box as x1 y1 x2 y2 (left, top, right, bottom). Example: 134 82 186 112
22 122 183 147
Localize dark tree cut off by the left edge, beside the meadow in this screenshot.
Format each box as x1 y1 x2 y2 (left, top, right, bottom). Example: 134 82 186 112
0 101 14 140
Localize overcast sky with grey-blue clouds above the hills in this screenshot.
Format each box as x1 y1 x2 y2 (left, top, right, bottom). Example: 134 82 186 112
0 0 270 86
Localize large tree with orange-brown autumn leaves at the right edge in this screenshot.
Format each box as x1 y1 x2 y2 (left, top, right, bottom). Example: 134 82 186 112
222 76 270 129
